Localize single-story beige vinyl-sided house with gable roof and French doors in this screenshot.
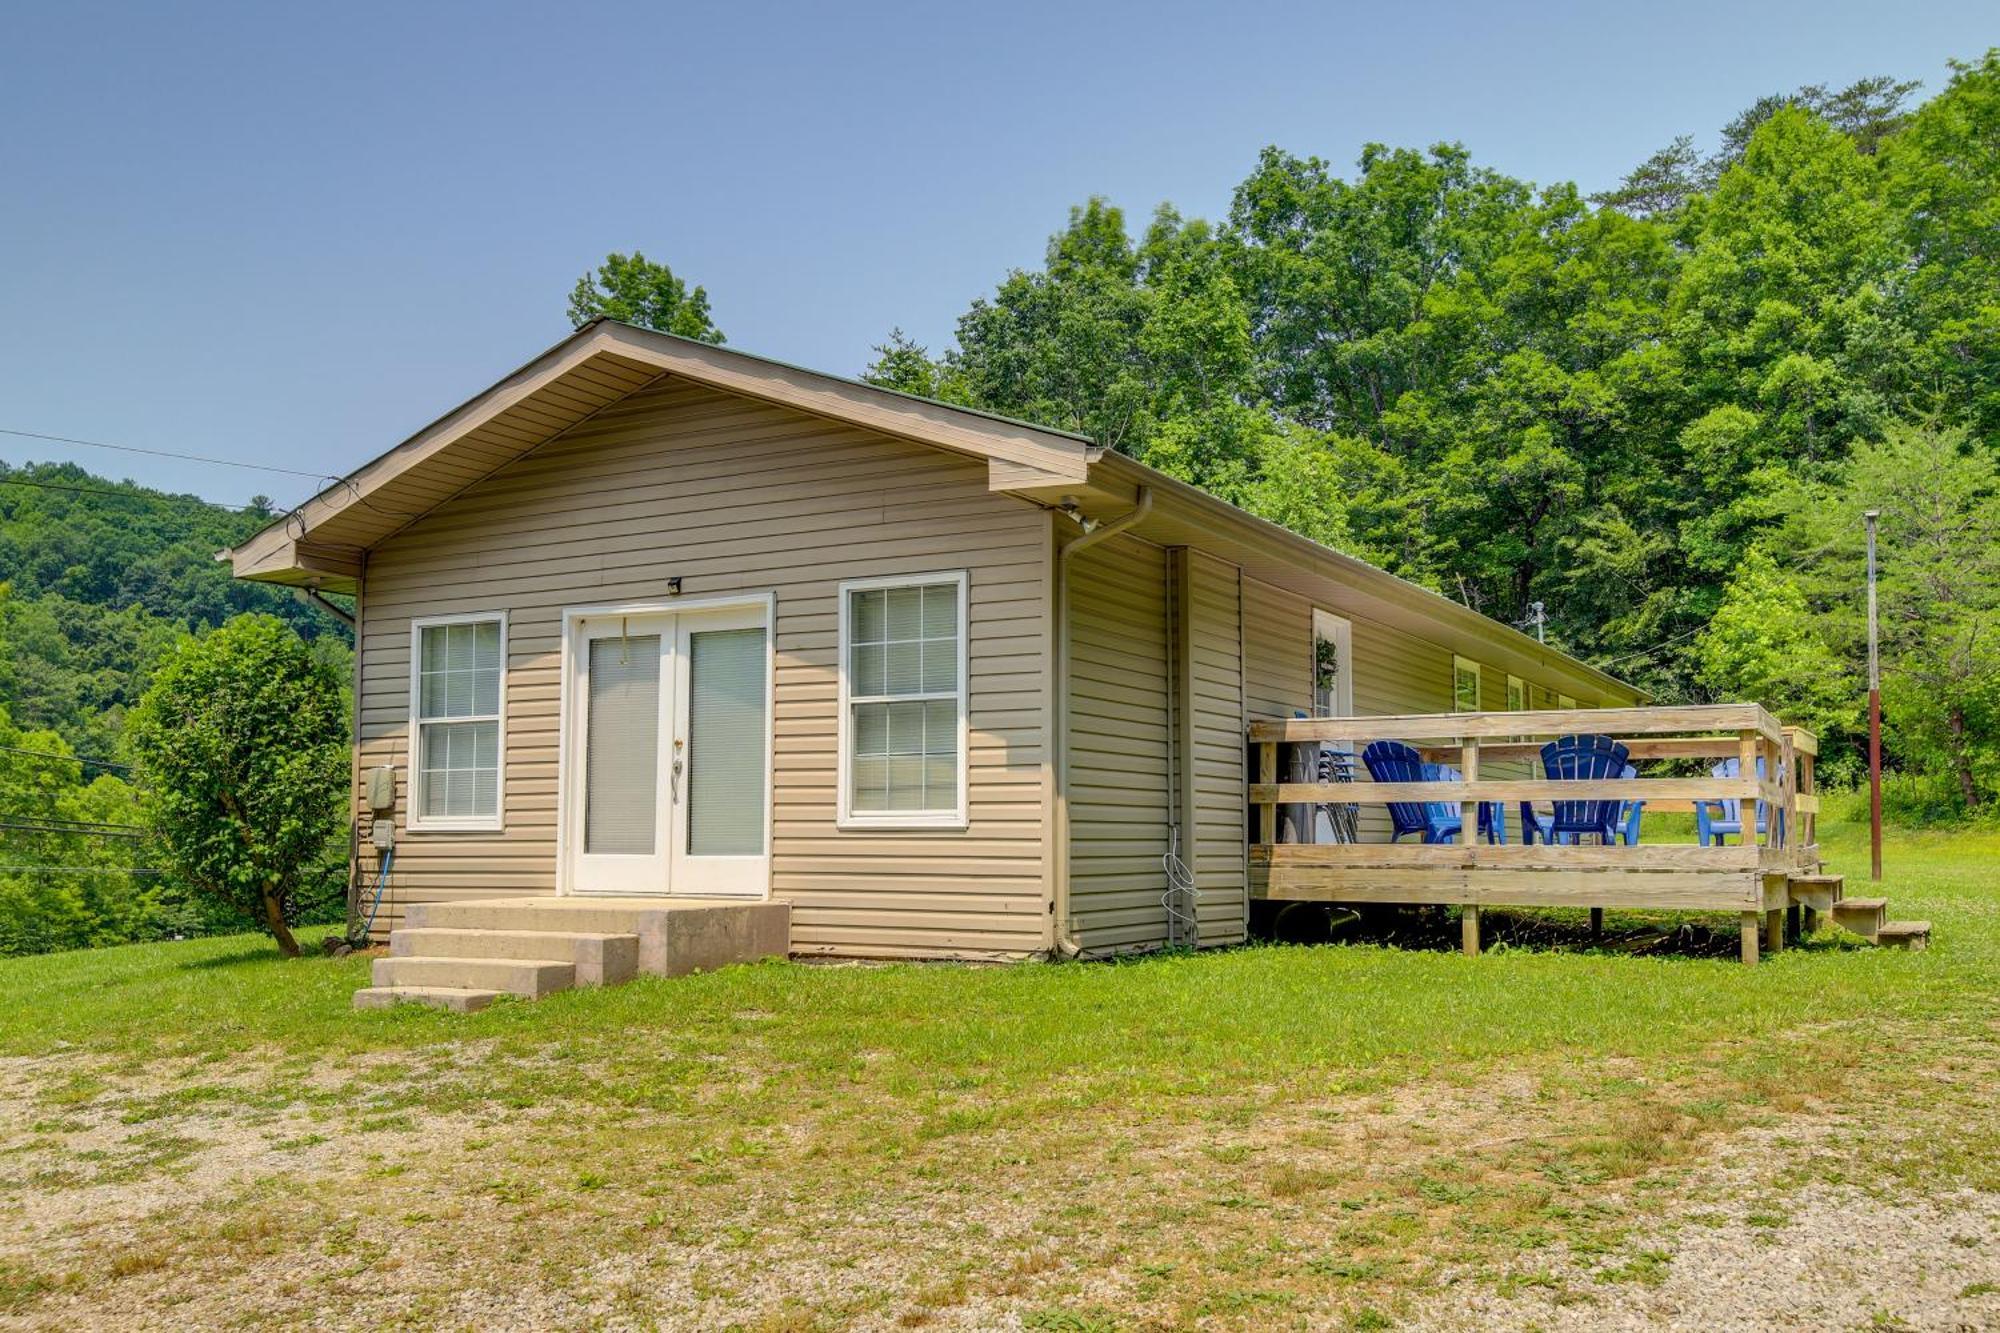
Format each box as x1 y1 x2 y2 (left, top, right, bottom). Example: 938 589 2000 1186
224 320 1640 996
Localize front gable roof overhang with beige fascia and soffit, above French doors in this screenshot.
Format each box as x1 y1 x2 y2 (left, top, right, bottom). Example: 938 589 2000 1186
218 320 1096 592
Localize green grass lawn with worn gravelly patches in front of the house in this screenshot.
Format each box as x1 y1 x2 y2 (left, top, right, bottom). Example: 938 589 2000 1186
0 825 2000 1327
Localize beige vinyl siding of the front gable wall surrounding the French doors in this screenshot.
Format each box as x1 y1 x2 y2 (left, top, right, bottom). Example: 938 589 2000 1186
360 380 1050 957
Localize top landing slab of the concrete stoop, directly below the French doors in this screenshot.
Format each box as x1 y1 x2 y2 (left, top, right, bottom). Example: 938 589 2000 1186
404 897 792 977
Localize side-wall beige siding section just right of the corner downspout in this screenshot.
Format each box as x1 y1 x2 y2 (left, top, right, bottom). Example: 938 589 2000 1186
1068 536 1170 953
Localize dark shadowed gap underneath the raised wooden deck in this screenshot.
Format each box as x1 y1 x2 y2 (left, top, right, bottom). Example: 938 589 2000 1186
1252 903 1838 959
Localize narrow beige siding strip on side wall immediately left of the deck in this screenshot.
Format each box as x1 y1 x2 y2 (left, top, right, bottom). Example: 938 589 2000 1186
1182 550 1248 945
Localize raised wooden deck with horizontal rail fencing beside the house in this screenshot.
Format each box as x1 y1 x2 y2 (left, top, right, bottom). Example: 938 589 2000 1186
1250 705 1820 963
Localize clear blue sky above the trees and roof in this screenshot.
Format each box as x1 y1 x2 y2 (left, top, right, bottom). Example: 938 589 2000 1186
0 0 2000 508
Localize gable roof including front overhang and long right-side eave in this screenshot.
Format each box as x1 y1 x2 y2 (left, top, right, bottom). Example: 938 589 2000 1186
218 318 1644 699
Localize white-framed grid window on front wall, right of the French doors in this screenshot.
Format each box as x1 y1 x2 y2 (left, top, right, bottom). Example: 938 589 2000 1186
838 570 966 829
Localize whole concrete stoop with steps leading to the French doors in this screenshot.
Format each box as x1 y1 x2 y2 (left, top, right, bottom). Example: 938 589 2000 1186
354 897 792 1013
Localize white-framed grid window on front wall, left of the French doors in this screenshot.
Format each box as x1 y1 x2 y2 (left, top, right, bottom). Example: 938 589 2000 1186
408 612 506 831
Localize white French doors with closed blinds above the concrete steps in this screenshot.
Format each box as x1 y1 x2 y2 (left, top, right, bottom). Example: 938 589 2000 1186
560 602 770 897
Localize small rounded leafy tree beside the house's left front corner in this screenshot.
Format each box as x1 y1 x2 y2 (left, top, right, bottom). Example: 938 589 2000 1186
128 616 348 955
